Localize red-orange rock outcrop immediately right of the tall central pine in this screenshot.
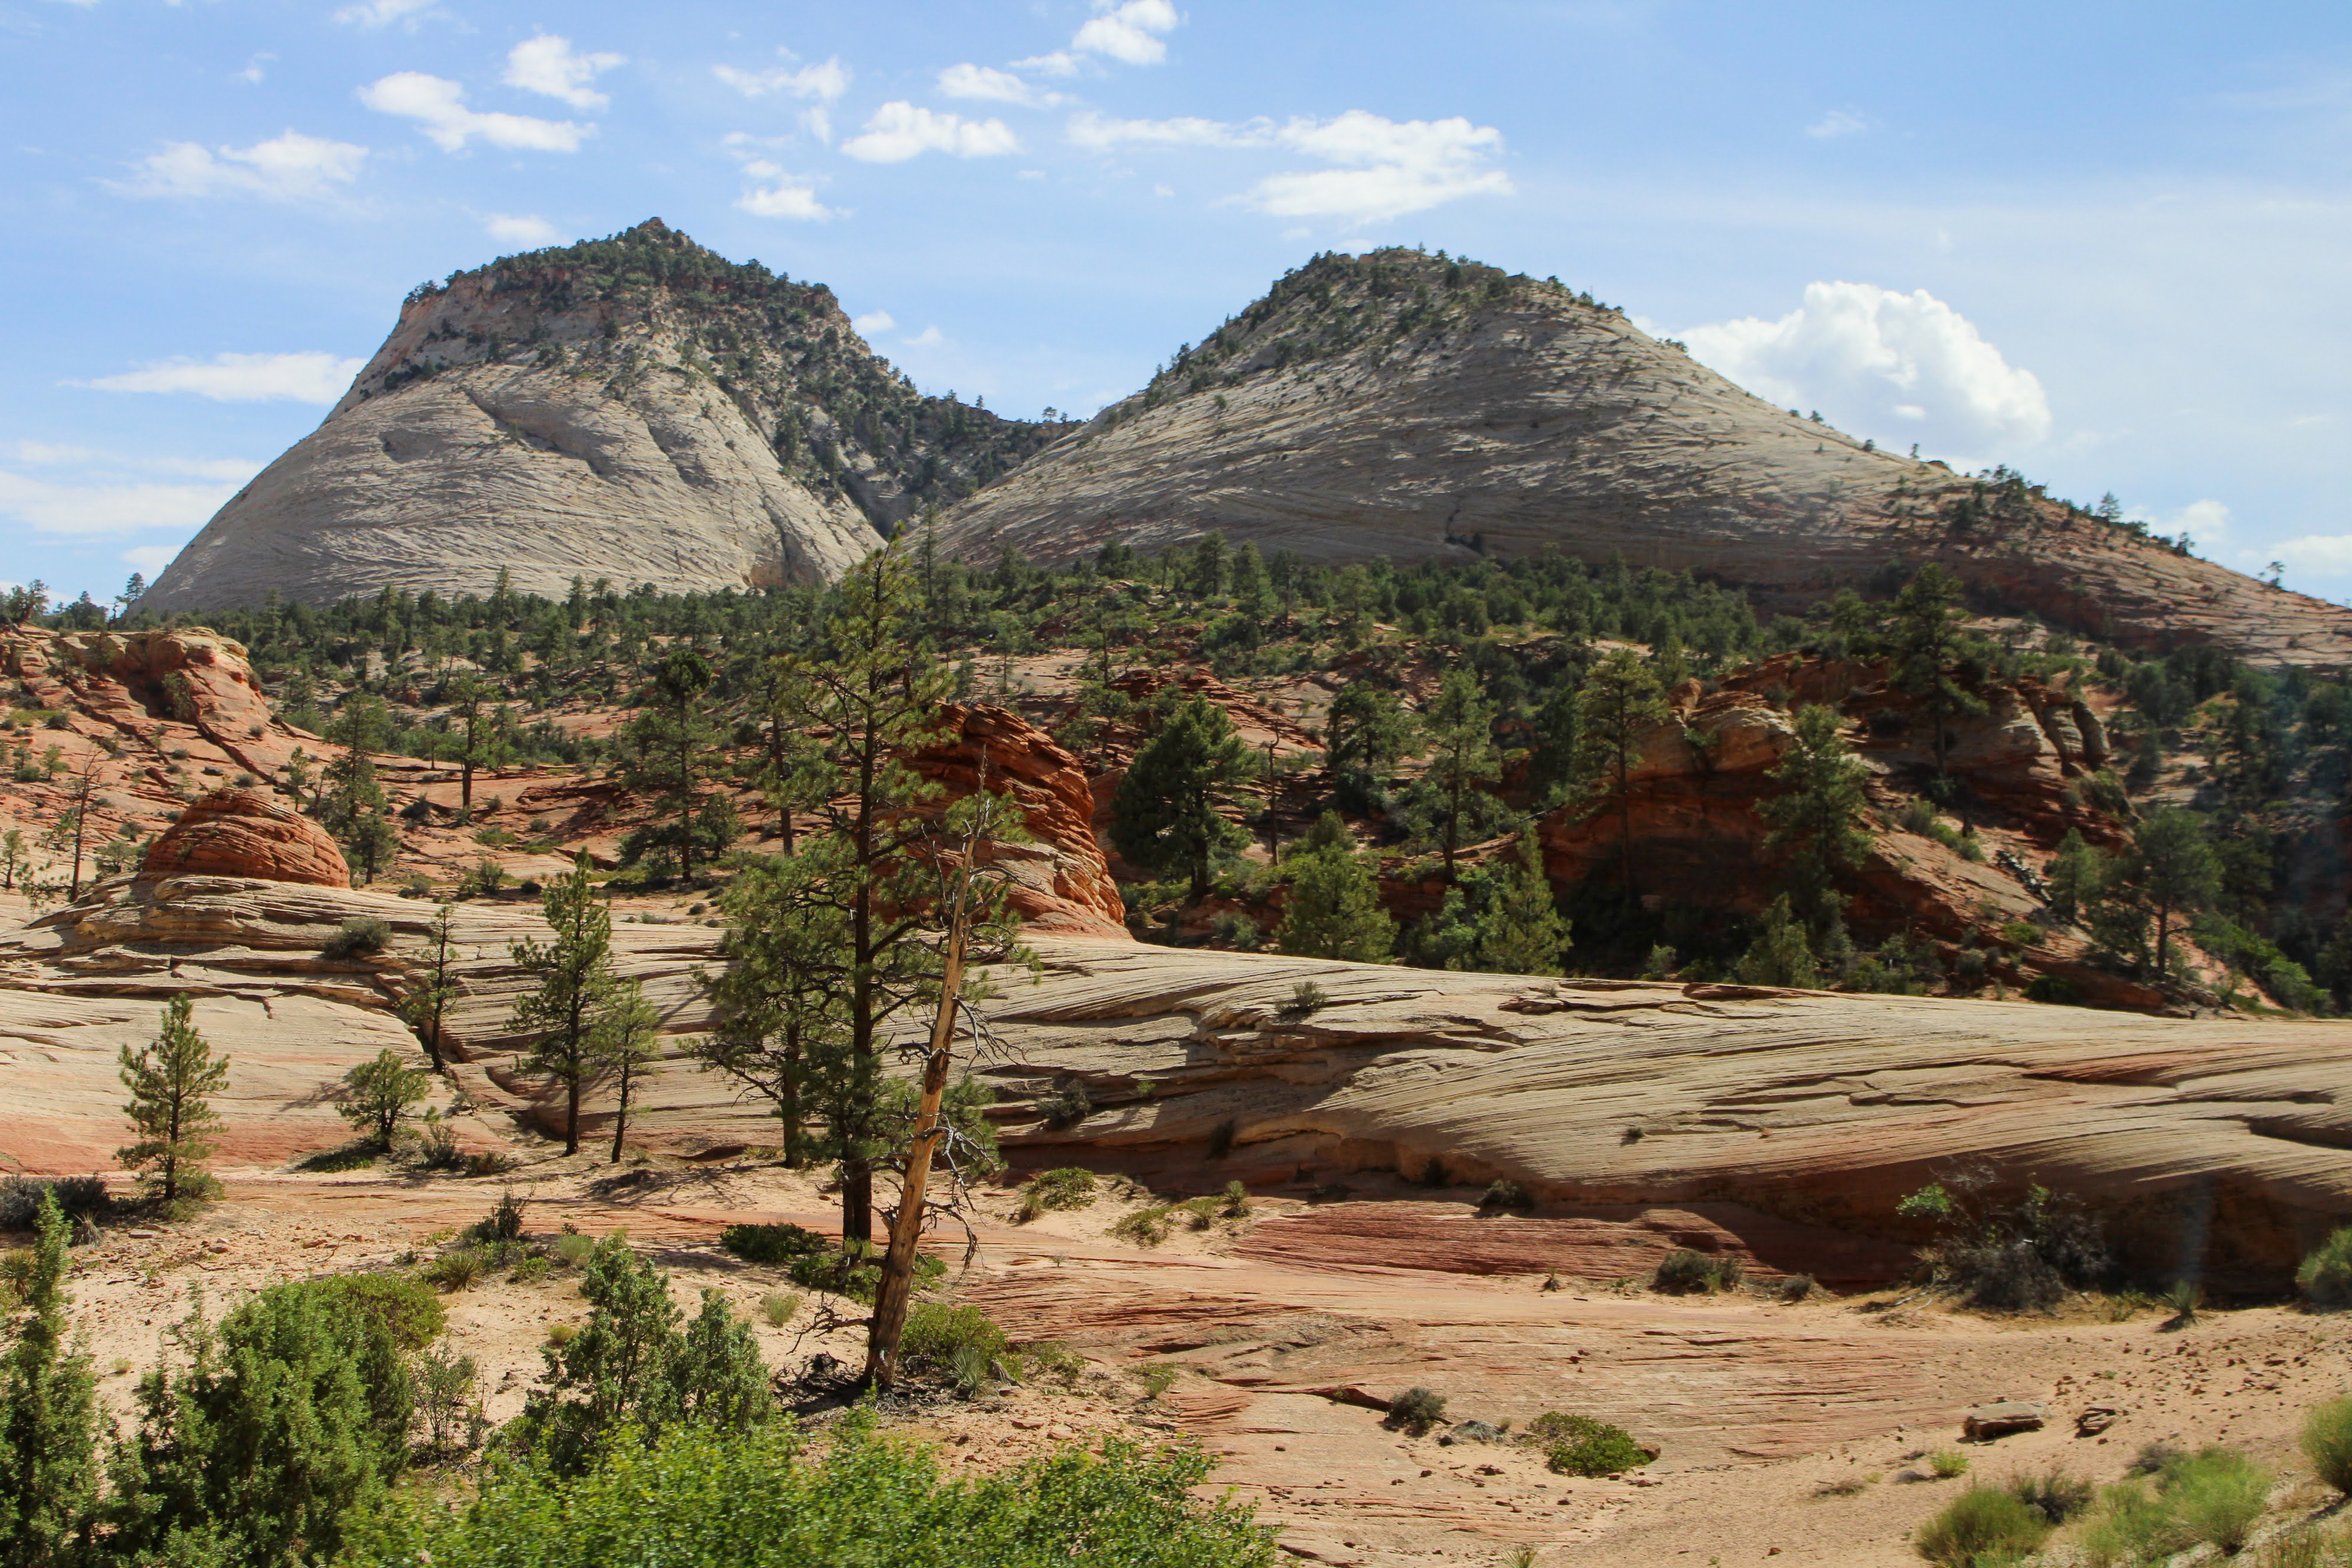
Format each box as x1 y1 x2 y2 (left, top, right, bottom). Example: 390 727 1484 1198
915 705 1126 938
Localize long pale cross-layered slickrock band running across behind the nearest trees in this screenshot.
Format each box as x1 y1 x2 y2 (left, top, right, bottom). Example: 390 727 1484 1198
0 877 2352 1288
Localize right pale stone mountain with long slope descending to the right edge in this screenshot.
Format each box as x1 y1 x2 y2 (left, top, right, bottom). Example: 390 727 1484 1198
943 249 2352 668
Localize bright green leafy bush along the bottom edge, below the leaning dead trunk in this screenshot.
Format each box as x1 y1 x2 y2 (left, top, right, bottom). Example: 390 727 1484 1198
348 1420 1275 1568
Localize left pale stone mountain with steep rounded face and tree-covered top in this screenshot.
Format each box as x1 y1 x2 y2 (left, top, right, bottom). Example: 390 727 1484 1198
146 218 1051 611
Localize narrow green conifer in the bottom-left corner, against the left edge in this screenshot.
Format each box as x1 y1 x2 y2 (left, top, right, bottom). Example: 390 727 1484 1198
0 1192 99 1568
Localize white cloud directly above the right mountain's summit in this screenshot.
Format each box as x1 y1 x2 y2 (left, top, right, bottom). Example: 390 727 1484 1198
1240 108 1513 223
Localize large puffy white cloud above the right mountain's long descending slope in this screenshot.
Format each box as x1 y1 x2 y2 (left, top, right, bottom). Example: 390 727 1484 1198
1680 282 2051 460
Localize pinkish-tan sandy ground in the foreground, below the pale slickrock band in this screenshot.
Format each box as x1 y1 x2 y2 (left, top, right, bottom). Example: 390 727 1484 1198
22 1157 2352 1568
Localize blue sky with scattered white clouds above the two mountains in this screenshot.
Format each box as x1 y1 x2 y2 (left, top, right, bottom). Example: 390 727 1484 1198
0 0 2352 599
